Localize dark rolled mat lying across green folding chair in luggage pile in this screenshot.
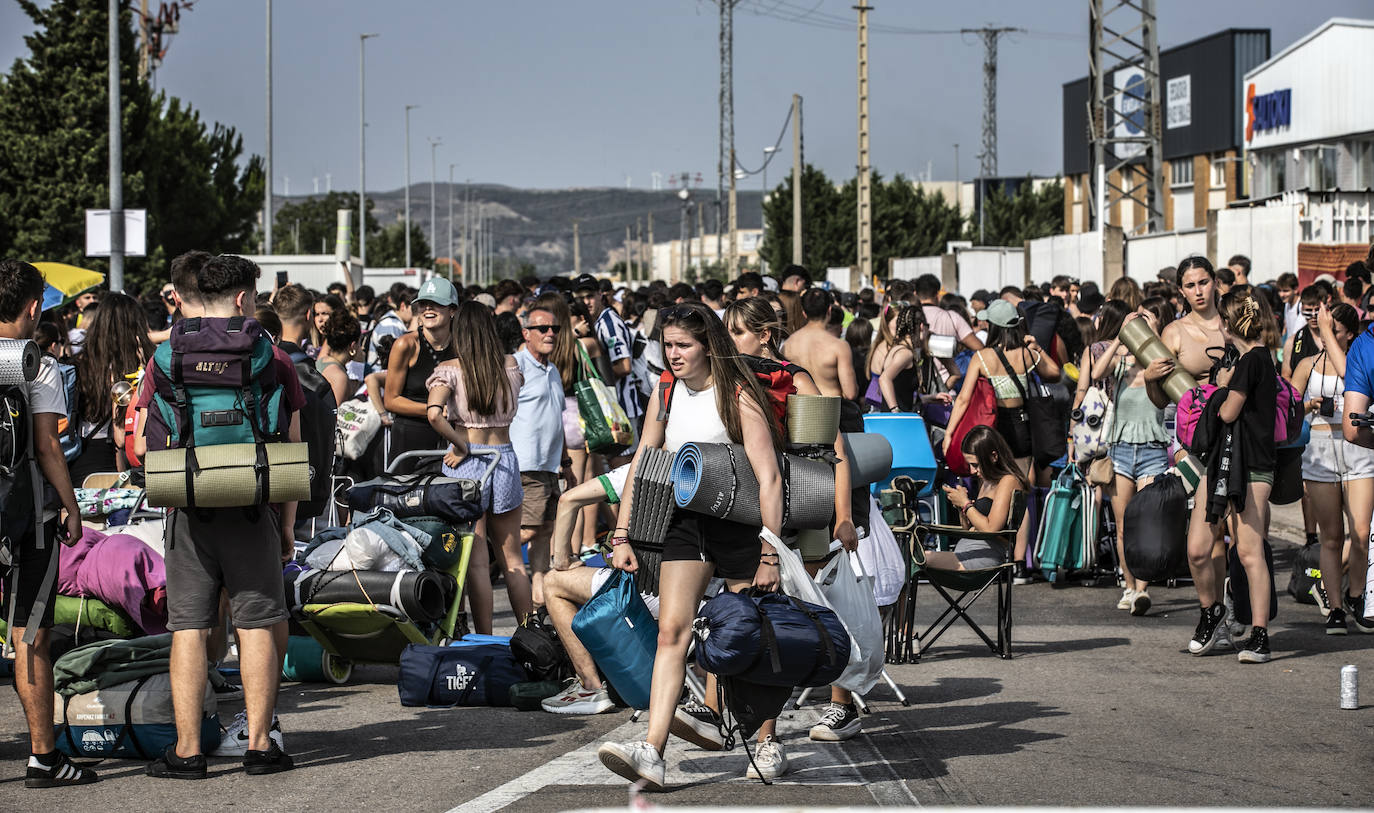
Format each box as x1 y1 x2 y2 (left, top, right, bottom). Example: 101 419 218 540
286 570 458 623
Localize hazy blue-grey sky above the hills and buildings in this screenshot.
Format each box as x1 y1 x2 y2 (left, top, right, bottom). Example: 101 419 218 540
0 0 1374 195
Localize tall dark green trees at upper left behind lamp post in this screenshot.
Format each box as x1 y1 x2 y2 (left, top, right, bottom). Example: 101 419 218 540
0 0 262 291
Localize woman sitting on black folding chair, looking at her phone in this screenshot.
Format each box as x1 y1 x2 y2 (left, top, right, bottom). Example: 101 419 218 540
926 426 1031 570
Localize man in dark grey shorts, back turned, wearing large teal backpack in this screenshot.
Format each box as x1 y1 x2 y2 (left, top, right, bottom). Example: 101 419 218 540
139 255 305 779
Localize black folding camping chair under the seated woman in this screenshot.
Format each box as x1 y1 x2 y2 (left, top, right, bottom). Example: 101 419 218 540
885 482 1026 662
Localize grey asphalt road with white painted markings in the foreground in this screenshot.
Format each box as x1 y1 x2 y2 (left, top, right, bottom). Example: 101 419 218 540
0 508 1374 813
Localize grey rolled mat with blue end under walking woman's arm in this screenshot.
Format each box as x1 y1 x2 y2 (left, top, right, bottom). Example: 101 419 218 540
672 444 835 530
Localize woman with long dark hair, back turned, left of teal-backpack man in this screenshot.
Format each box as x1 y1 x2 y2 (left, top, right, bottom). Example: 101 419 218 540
67 293 154 488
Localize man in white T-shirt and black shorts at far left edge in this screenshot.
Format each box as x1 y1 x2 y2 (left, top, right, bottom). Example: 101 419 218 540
0 260 96 788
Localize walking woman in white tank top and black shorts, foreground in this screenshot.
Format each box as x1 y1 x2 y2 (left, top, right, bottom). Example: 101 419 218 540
598 302 786 790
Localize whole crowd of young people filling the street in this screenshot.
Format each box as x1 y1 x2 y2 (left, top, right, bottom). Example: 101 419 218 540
0 245 1374 787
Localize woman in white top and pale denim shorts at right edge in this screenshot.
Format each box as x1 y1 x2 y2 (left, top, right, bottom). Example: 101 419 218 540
1293 302 1374 634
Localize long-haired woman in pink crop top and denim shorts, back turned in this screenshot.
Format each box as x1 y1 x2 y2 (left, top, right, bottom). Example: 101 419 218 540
426 302 534 634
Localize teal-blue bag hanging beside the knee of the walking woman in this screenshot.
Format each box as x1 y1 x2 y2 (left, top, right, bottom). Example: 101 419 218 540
573 570 658 709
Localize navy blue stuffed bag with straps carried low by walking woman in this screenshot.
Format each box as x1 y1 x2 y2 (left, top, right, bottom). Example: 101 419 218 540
692 592 849 687
